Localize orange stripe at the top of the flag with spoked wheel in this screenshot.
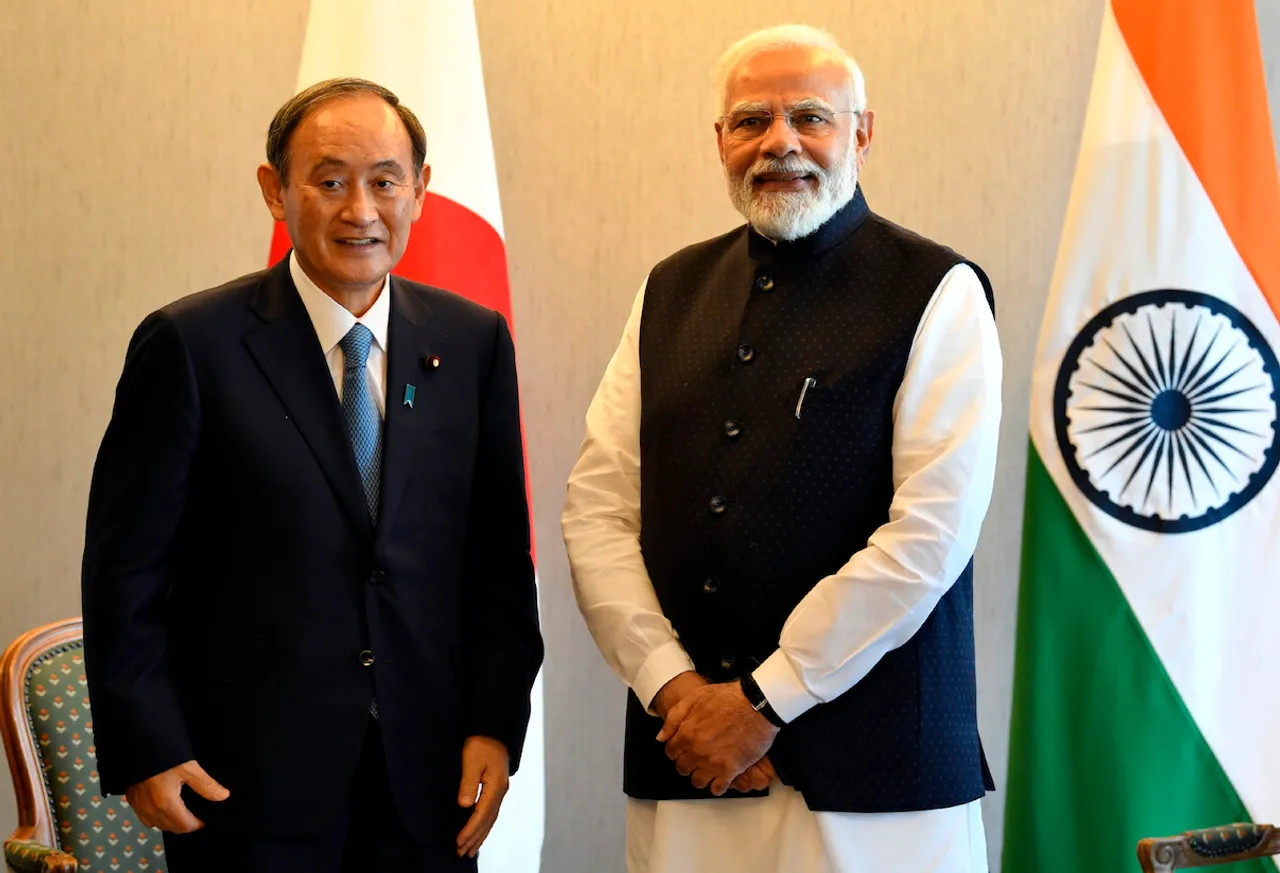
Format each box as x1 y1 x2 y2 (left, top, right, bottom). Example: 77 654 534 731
1111 0 1280 319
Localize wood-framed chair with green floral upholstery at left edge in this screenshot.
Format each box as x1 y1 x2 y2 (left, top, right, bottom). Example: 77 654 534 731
0 618 165 873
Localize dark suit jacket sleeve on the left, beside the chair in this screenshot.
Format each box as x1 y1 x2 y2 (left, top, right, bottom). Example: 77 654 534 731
81 312 200 794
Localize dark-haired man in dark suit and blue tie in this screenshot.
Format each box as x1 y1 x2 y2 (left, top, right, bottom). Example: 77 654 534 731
83 79 543 873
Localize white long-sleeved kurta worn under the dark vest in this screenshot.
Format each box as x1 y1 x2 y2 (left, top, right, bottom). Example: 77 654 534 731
562 259 1002 873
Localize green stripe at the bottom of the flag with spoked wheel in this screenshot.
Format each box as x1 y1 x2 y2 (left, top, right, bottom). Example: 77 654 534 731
1002 444 1275 873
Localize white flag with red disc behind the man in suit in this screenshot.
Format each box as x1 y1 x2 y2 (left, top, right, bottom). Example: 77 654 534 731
270 0 545 873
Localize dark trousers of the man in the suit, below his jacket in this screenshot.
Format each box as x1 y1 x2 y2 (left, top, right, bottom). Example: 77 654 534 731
164 719 476 873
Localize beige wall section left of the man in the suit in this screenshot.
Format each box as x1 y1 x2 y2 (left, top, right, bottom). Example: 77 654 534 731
0 0 306 836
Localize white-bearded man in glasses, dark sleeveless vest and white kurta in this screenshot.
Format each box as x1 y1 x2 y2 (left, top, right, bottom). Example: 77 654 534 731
563 26 1001 873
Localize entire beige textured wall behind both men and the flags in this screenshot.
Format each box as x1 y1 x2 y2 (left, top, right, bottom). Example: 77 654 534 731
0 0 1280 873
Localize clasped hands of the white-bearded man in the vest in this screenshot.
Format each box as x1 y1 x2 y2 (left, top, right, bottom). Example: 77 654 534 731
658 682 778 796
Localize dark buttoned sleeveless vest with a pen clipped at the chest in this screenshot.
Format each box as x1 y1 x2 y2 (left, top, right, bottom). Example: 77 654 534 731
623 189 993 812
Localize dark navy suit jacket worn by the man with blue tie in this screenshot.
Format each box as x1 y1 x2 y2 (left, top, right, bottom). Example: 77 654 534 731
82 259 543 845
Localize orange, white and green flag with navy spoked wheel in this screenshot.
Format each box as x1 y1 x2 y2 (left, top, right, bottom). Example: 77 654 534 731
1004 0 1280 873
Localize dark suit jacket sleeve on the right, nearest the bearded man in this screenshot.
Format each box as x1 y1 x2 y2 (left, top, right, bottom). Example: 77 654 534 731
465 315 543 772
